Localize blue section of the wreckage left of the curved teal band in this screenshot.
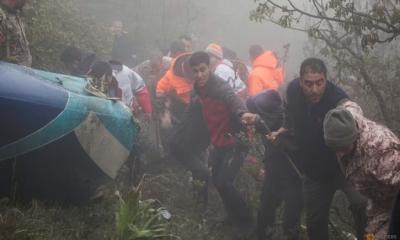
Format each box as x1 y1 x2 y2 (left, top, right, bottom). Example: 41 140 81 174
0 62 68 147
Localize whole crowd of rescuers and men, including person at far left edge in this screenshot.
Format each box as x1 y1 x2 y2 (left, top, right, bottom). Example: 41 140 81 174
0 0 400 240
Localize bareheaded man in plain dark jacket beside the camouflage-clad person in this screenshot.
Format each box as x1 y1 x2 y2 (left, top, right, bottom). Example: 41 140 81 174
268 58 366 240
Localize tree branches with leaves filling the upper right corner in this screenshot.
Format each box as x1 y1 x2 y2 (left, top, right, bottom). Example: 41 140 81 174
251 0 400 132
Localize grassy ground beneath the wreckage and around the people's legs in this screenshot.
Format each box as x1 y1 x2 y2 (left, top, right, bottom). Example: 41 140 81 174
0 153 356 240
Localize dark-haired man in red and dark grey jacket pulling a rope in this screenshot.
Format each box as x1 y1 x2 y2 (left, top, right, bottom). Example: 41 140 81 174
189 52 257 237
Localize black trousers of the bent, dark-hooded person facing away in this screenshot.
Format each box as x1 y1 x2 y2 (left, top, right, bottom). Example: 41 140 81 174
257 147 303 240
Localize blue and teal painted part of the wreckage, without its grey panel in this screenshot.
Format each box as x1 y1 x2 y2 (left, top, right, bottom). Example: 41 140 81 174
0 62 138 159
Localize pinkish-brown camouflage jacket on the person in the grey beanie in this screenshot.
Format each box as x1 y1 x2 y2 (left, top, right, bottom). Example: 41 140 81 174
341 101 400 239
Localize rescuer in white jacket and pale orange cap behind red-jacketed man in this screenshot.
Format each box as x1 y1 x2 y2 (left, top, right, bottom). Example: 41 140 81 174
205 43 246 99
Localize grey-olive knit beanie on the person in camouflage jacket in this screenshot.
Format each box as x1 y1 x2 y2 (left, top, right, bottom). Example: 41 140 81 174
324 107 359 149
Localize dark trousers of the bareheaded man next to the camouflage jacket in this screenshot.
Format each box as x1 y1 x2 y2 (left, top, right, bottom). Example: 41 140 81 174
303 174 367 240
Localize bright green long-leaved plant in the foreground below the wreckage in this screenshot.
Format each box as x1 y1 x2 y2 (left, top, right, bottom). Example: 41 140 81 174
116 184 179 240
